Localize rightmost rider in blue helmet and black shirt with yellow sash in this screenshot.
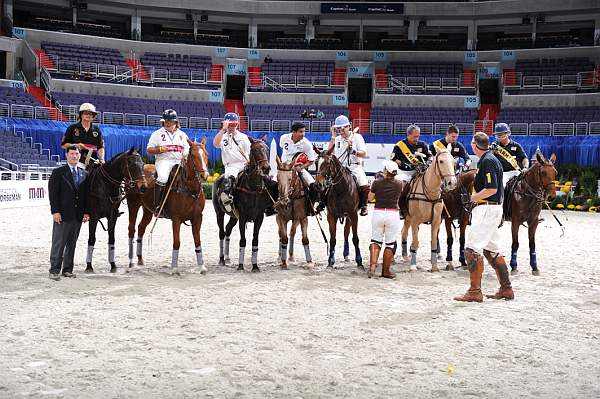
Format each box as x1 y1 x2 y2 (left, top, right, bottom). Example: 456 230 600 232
492 123 529 185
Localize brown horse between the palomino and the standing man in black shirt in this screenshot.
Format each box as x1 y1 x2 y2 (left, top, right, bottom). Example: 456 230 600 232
438 169 477 270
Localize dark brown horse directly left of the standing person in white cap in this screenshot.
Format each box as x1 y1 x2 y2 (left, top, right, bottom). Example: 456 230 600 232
315 148 365 271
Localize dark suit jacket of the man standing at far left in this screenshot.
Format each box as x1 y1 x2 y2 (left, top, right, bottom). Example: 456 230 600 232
48 164 89 222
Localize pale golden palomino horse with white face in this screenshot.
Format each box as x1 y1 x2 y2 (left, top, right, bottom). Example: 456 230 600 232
402 146 456 272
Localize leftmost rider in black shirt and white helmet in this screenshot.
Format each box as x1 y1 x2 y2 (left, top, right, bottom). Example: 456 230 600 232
60 103 104 168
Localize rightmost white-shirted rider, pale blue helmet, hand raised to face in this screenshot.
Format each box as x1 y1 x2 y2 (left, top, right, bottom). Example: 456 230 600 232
323 115 369 216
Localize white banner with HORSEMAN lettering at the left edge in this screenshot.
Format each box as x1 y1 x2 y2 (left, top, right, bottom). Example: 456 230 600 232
0 180 50 209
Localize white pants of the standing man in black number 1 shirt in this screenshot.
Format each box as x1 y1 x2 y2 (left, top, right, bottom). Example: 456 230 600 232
465 205 502 255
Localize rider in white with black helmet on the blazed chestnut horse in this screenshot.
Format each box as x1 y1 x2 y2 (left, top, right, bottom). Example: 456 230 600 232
146 109 190 214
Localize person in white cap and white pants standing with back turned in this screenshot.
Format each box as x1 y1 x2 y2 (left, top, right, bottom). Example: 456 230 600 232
368 160 404 278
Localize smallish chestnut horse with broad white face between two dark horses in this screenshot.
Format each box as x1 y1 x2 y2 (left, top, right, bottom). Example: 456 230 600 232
276 157 313 269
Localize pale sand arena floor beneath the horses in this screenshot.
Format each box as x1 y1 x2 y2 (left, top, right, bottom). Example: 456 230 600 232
0 206 600 398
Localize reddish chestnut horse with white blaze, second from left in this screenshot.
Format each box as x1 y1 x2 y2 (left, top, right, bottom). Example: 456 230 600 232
127 139 208 273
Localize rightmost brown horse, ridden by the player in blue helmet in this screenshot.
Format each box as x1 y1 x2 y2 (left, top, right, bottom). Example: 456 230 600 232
504 151 558 276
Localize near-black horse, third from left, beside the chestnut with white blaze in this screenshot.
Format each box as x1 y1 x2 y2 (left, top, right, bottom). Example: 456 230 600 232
212 137 277 273
